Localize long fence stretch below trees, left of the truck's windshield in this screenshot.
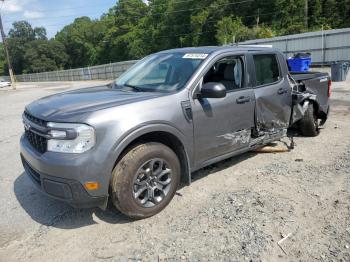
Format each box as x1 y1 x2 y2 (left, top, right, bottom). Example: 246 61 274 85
11 60 137 82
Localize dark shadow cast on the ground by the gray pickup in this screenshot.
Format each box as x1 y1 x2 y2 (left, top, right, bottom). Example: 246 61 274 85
14 152 256 229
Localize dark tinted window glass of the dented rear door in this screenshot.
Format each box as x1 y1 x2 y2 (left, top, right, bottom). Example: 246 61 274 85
253 54 280 86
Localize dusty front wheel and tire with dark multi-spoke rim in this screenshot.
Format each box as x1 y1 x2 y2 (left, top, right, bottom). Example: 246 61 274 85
111 142 181 219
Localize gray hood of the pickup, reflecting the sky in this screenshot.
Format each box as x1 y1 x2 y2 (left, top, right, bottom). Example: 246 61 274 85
26 86 164 122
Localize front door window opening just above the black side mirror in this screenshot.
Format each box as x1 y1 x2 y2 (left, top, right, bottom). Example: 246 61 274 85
203 56 244 91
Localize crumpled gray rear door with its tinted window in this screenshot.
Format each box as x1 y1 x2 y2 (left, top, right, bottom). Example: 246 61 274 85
251 53 292 132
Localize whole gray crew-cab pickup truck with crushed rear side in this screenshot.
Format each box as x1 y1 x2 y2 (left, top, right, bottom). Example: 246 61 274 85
20 46 331 218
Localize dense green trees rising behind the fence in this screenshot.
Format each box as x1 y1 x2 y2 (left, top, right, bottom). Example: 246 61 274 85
0 0 350 74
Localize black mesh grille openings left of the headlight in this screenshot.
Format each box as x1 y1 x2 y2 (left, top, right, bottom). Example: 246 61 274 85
24 111 47 154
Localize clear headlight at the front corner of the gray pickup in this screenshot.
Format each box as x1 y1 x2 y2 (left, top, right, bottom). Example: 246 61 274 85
47 122 95 154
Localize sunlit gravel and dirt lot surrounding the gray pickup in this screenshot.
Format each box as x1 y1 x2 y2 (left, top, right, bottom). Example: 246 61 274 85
0 77 350 261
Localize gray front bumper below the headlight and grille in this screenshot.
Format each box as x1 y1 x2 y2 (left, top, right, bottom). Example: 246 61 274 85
21 136 108 208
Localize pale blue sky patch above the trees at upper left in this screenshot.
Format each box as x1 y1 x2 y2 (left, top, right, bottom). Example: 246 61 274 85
0 0 117 38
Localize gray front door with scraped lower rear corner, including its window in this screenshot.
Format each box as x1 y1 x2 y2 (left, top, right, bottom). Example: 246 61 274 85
192 56 255 165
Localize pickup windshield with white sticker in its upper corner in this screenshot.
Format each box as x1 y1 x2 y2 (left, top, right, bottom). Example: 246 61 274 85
116 53 207 92
